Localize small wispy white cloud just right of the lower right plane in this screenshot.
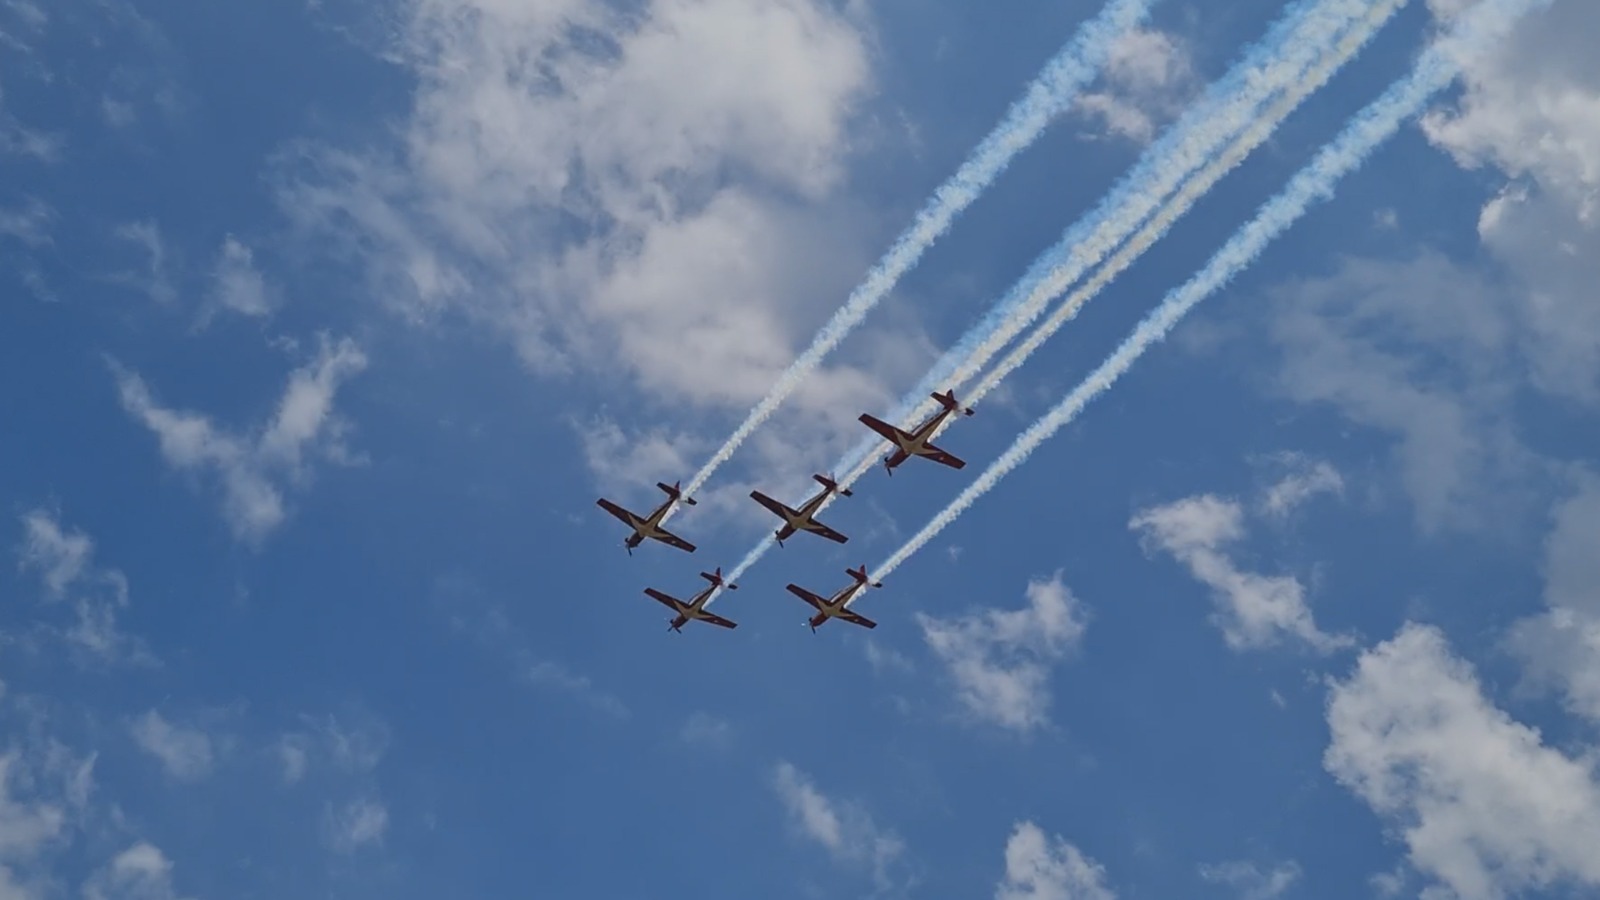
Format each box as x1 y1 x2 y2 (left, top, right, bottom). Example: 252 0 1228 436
917 572 1088 732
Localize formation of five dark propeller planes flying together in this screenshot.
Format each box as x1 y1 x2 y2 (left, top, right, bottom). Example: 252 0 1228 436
597 391 973 633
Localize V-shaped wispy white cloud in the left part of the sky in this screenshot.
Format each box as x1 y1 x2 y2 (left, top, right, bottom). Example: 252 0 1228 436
114 338 366 544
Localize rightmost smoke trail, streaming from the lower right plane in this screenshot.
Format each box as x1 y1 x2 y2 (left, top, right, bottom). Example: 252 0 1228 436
874 0 1550 578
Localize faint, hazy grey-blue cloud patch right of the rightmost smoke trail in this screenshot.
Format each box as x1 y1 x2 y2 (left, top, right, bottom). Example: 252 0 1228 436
1270 253 1534 532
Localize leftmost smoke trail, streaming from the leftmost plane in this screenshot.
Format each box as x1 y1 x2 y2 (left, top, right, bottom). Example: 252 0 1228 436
667 0 1160 517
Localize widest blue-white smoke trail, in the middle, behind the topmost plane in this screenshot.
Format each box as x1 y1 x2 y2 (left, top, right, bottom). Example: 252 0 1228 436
840 0 1406 484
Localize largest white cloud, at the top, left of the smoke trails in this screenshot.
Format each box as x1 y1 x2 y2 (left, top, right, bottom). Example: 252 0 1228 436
280 0 902 480
